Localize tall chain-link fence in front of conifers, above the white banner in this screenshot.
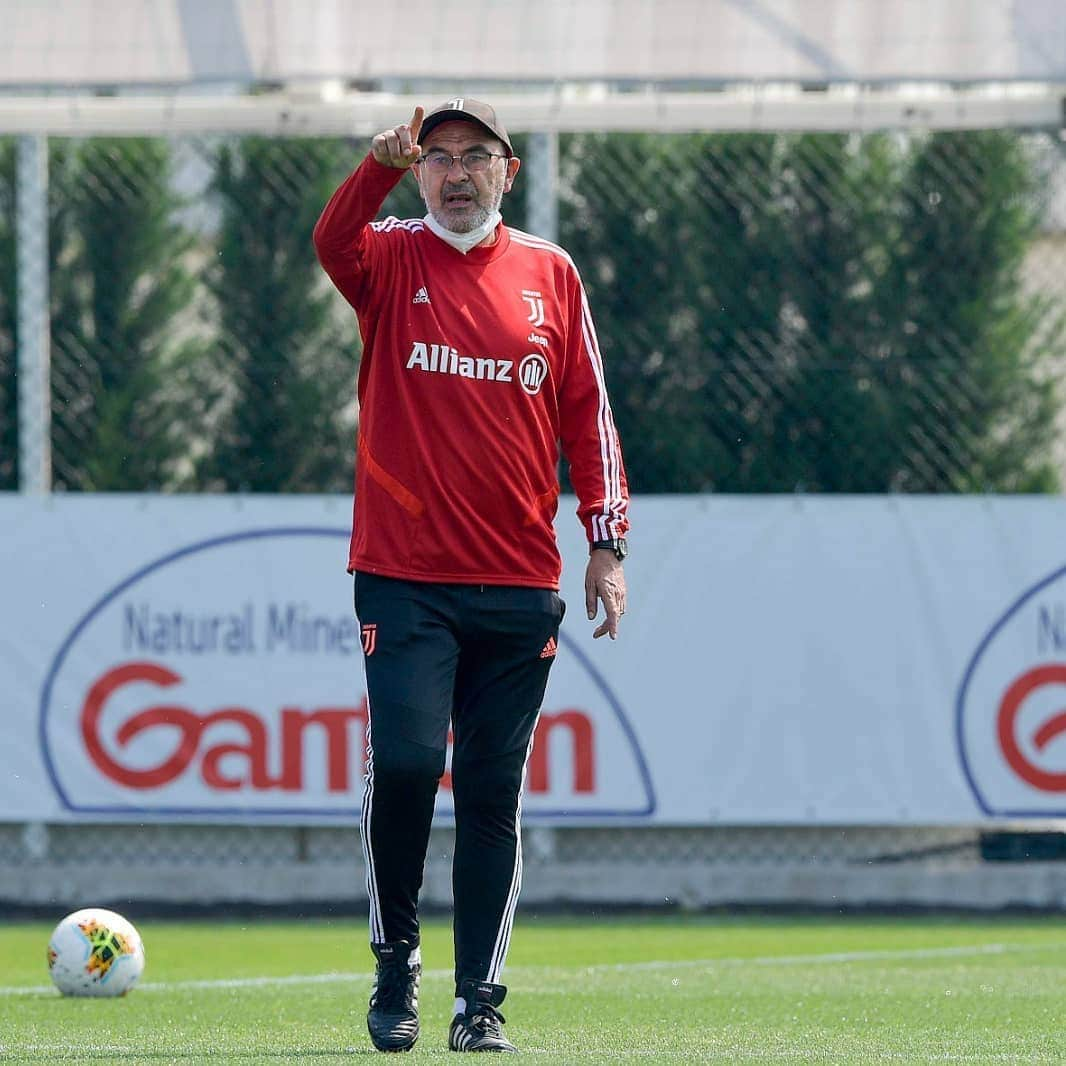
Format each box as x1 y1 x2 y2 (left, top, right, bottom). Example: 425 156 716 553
0 131 1066 492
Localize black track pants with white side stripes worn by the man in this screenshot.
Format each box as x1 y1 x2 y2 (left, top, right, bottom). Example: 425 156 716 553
355 574 564 983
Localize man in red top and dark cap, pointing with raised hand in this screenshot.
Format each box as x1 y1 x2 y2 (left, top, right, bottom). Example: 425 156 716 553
314 99 628 1051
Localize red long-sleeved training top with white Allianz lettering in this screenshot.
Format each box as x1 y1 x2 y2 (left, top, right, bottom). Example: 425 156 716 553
314 156 629 588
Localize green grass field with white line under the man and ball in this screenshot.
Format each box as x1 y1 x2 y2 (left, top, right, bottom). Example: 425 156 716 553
0 915 1066 1066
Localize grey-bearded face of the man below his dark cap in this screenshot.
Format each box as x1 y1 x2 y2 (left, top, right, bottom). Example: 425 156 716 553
415 122 521 233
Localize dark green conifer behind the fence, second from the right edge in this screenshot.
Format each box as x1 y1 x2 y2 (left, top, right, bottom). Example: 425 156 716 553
767 134 909 492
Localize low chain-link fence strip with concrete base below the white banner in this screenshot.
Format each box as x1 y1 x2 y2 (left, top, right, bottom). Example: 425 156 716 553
8 823 1066 914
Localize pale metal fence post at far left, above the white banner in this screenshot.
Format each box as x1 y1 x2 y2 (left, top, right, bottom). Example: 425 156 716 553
15 135 52 495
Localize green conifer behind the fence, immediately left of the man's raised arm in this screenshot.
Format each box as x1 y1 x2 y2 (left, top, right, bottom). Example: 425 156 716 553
199 136 358 492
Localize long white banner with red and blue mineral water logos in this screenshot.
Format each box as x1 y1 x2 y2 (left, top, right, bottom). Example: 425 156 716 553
0 496 1066 824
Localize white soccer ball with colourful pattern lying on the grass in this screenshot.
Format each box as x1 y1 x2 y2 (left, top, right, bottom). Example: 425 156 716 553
48 907 144 996
